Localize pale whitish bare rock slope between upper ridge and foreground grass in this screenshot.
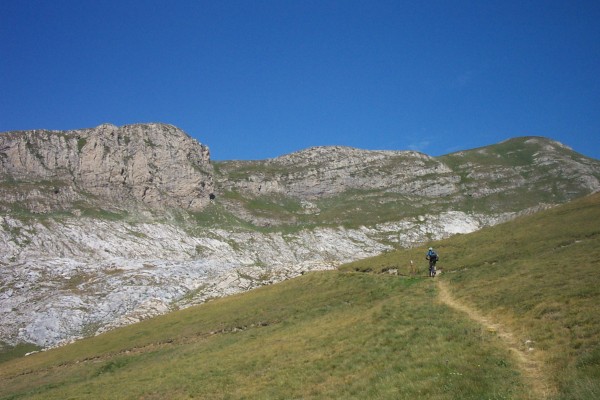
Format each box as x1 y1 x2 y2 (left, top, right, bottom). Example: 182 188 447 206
0 212 511 347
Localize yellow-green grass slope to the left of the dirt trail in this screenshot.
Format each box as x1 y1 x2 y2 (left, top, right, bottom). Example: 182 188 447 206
0 271 523 399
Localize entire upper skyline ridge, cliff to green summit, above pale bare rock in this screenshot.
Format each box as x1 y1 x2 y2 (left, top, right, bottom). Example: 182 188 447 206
0 124 600 222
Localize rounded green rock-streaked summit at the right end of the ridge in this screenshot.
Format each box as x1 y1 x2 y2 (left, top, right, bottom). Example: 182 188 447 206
439 136 600 212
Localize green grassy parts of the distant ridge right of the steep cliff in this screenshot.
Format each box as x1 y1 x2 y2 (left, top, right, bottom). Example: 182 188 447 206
209 136 600 229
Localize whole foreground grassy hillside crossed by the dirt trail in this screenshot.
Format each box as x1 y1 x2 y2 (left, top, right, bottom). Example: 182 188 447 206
0 195 600 399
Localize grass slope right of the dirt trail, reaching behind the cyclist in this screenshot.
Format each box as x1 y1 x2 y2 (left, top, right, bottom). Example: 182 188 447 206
345 194 600 399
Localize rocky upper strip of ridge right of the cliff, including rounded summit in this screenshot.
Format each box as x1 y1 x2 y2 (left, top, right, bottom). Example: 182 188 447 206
217 137 599 200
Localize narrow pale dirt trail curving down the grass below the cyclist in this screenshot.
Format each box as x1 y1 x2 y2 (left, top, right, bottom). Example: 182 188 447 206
436 279 554 399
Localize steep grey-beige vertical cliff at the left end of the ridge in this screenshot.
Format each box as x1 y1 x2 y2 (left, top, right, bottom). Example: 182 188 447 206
0 124 214 212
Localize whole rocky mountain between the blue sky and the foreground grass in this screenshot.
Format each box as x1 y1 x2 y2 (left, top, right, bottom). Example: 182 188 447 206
0 124 600 347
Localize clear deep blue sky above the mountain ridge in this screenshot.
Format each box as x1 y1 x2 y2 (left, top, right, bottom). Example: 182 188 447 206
0 0 600 160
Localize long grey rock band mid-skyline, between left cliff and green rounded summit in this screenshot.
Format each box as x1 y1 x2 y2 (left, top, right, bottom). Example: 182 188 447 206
217 146 459 200
